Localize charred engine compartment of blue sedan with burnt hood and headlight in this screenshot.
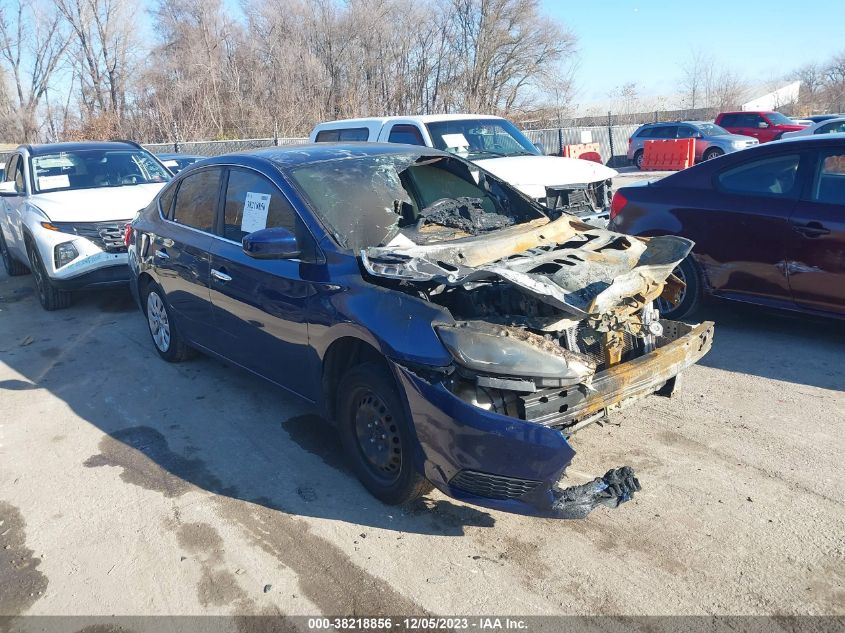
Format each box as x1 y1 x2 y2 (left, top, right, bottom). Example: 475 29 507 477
361 215 692 430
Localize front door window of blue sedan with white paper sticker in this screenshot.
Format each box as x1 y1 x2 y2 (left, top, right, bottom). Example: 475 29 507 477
223 169 297 242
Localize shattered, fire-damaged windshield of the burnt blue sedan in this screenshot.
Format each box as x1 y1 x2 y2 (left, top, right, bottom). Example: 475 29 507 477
289 153 545 252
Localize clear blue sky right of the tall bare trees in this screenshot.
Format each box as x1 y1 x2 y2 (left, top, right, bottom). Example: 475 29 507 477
541 0 845 104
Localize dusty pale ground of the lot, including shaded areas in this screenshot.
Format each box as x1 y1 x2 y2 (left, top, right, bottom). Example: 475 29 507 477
0 260 845 615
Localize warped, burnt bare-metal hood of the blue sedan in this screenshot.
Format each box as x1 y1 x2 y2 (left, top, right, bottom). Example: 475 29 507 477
361 216 692 320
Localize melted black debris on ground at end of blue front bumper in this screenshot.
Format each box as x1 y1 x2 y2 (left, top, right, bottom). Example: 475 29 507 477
551 466 642 519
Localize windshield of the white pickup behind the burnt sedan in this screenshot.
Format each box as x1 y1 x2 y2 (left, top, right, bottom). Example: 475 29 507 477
426 119 540 158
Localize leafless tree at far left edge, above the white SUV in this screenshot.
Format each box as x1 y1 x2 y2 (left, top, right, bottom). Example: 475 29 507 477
0 0 69 142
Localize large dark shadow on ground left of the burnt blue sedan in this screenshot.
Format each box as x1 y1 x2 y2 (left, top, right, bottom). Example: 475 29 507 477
0 272 495 536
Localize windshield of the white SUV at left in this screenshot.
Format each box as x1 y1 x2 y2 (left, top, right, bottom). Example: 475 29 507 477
31 149 171 193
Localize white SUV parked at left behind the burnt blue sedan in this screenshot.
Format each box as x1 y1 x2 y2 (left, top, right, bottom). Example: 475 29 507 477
0 141 171 310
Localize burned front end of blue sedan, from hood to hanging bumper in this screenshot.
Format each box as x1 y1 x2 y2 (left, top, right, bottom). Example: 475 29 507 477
361 215 713 518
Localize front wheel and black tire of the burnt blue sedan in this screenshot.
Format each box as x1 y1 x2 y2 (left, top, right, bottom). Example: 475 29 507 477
337 362 431 505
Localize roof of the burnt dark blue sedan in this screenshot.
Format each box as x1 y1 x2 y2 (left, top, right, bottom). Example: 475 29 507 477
205 142 452 167
